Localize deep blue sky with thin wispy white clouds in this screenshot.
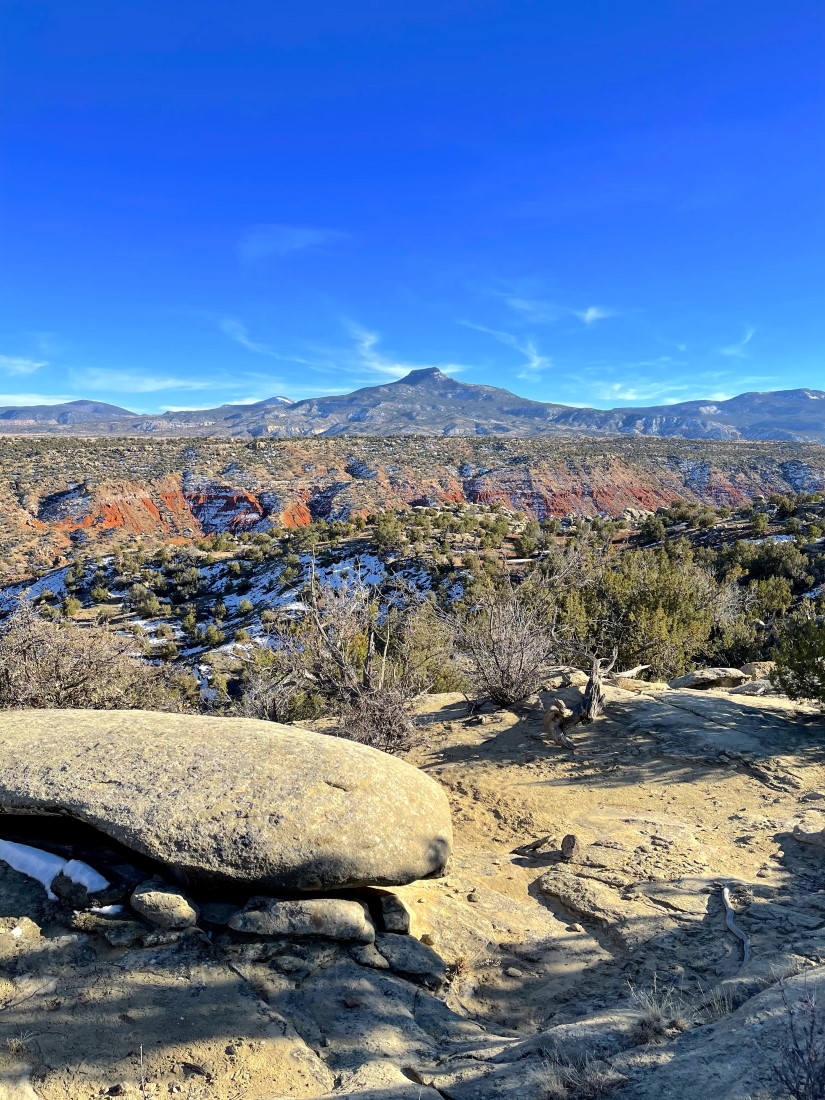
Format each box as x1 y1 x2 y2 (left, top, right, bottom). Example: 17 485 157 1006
0 0 825 411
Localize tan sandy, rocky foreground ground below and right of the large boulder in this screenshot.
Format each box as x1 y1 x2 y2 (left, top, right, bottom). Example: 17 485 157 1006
0 681 825 1100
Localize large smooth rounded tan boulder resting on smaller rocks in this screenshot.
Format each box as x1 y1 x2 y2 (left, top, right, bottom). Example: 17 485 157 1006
0 711 451 892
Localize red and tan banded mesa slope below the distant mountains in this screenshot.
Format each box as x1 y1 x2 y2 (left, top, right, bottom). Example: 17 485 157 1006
0 439 825 552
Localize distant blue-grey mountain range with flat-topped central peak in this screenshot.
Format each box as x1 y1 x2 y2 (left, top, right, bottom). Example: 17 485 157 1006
0 367 825 443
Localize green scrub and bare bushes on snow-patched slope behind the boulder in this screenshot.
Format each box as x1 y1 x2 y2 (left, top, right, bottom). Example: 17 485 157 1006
0 494 825 749
